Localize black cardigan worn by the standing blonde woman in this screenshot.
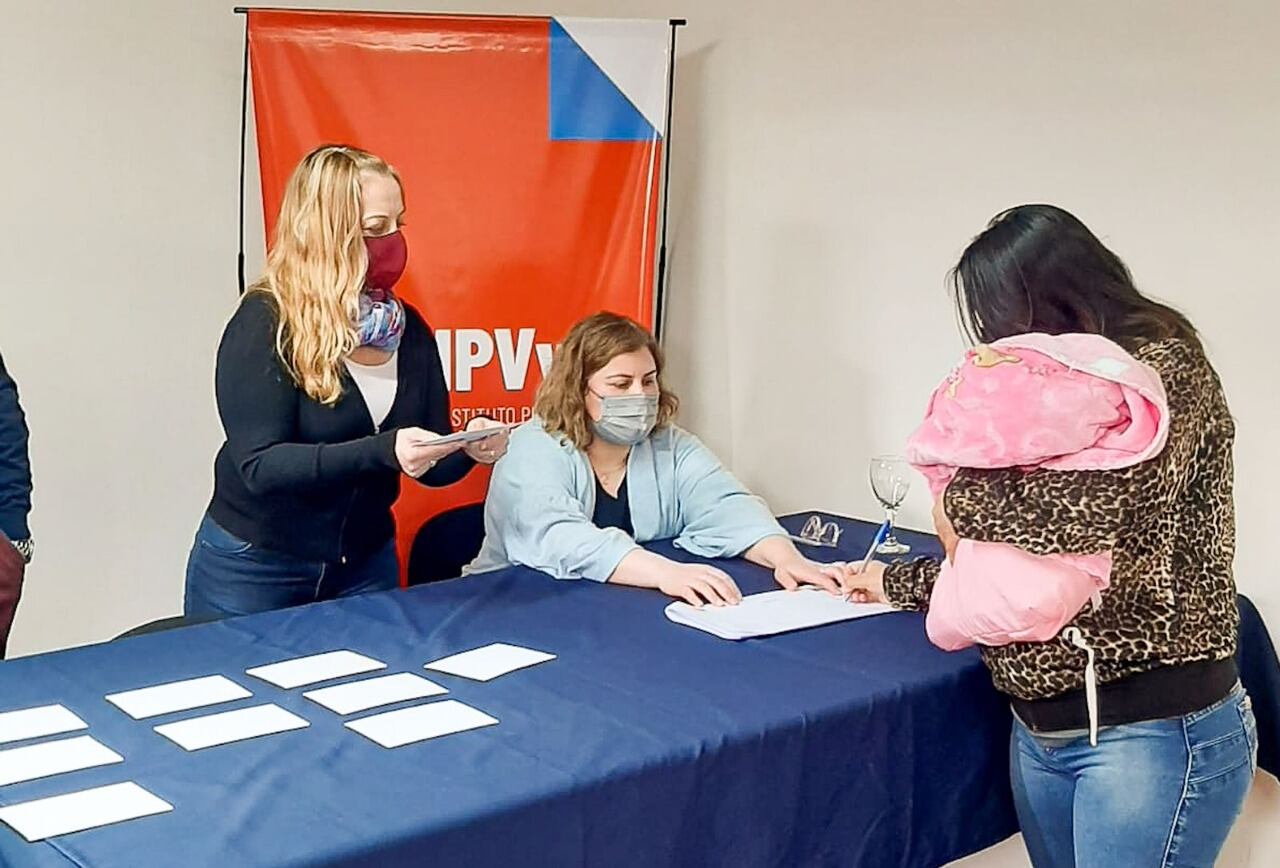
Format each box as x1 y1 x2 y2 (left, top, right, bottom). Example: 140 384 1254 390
209 292 474 563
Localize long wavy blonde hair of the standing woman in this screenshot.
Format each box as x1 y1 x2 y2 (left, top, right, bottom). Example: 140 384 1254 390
251 145 399 405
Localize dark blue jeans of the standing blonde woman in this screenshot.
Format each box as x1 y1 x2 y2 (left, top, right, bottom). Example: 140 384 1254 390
183 515 399 621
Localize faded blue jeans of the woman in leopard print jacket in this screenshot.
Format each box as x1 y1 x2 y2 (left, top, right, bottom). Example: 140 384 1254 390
1010 685 1258 868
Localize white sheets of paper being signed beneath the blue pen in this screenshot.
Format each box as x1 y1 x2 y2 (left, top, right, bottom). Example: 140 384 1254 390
667 588 897 639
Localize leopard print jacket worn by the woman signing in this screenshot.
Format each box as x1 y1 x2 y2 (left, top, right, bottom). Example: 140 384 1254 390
884 338 1239 700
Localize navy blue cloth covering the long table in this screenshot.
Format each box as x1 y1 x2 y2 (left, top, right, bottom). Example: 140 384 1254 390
0 525 1015 868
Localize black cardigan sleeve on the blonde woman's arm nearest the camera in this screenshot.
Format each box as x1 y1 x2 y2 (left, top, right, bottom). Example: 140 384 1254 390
215 293 399 494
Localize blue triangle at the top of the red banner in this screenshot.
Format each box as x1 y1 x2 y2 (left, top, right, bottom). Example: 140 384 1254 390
547 19 658 142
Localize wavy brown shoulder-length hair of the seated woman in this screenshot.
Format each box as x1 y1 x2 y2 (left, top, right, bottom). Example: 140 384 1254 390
534 311 680 449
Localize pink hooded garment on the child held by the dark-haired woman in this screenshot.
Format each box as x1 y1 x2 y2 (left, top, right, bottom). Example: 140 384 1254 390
906 334 1169 650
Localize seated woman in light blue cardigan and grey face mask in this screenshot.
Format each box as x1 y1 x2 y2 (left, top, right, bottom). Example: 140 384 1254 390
467 314 841 606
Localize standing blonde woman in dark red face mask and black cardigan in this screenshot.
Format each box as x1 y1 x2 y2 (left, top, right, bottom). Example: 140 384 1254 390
184 146 506 620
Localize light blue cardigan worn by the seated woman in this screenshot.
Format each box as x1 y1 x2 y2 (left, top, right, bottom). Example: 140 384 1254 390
465 419 786 581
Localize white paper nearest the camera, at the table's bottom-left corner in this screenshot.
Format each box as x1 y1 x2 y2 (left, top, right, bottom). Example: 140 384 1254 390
0 781 173 841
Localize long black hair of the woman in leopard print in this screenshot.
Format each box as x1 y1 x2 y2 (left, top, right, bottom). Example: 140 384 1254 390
950 205 1198 350
